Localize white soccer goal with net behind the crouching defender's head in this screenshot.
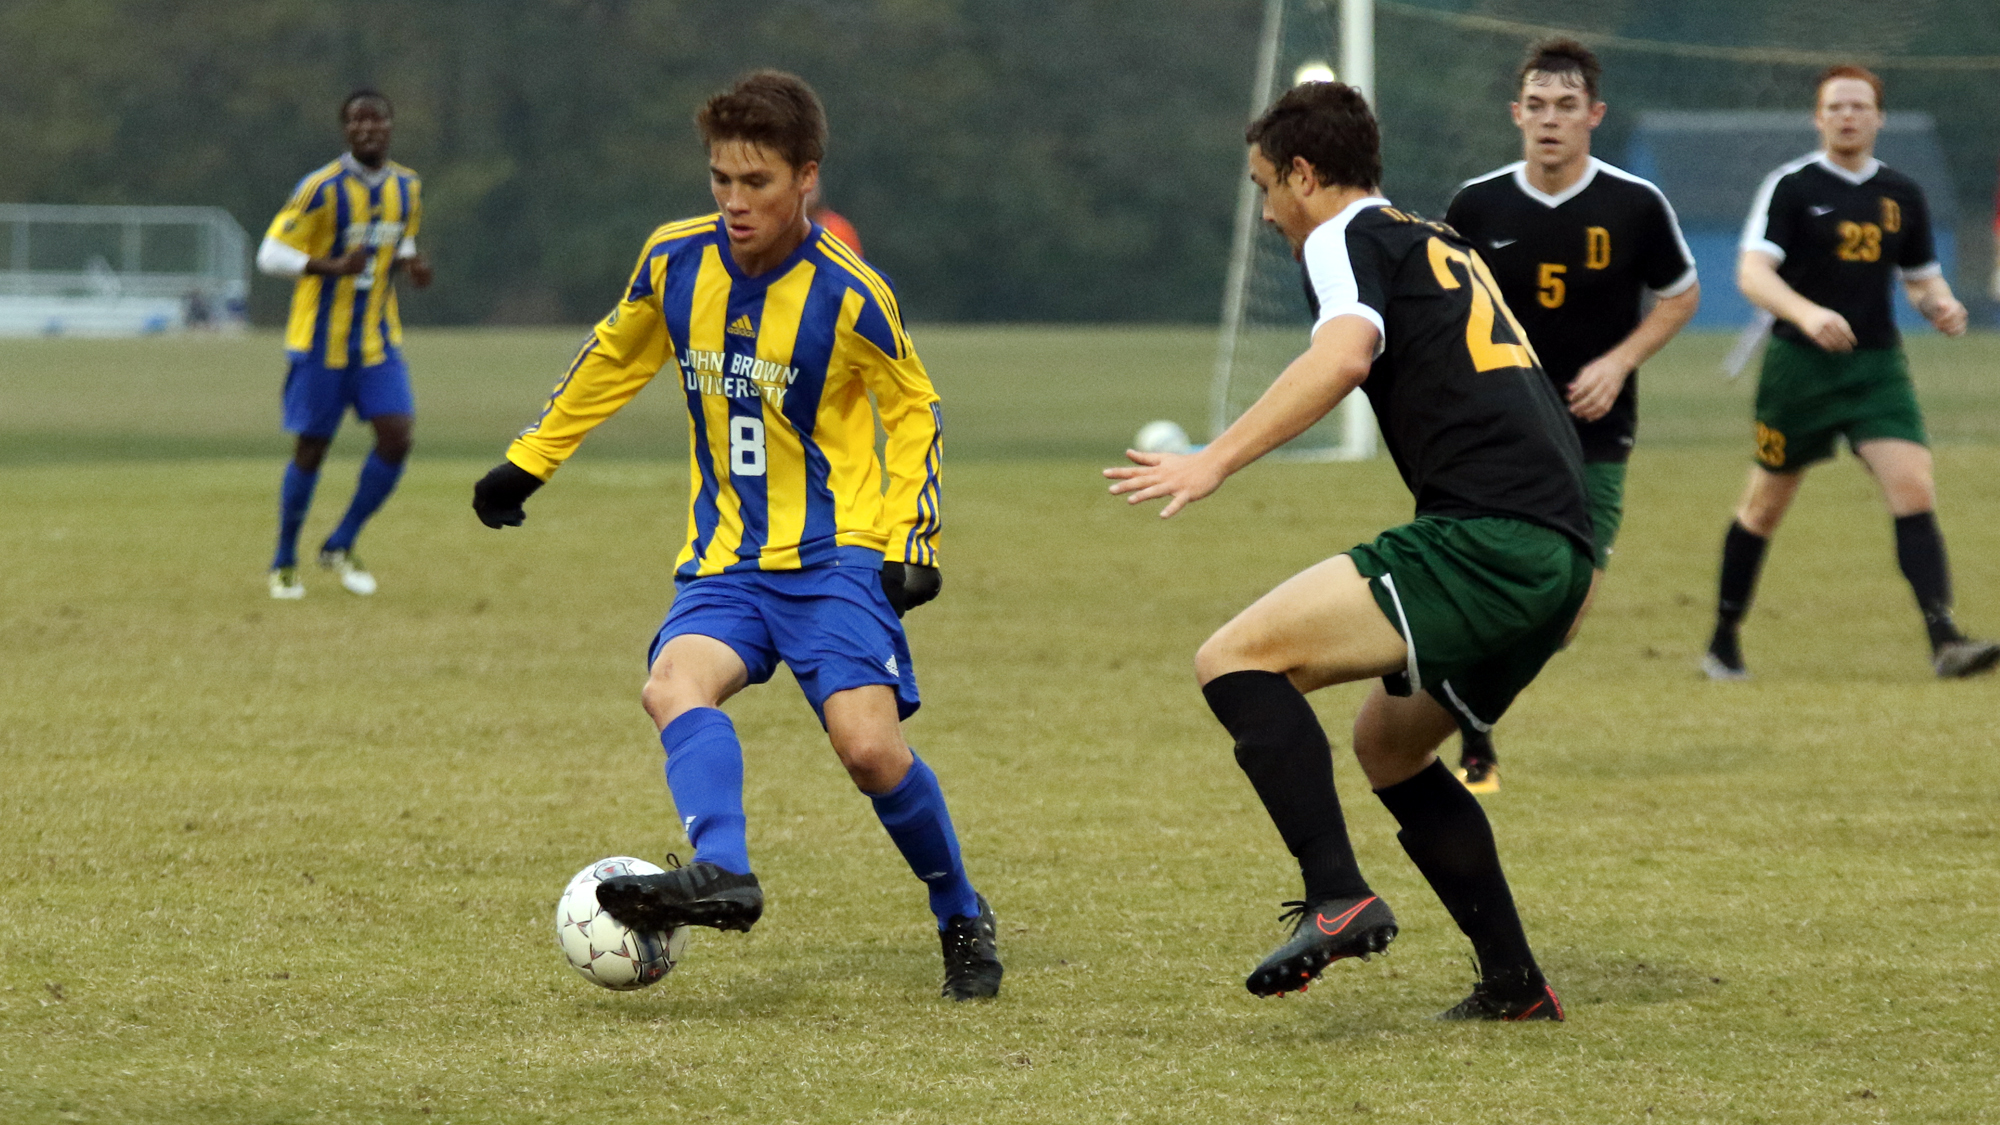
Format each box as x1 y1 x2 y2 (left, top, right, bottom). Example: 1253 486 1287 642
1208 0 1376 460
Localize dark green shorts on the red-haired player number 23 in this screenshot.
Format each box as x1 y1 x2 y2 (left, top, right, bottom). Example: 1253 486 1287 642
1756 336 1930 472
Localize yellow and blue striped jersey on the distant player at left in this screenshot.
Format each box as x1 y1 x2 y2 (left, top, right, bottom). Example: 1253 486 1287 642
266 158 424 368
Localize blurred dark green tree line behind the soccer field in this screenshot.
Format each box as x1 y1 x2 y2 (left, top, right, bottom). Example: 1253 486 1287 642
0 0 2000 324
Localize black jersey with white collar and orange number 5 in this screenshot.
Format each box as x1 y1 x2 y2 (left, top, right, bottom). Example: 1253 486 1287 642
1444 158 1694 460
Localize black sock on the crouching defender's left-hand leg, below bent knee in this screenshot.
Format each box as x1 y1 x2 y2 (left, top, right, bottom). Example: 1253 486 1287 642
1202 673 1376 903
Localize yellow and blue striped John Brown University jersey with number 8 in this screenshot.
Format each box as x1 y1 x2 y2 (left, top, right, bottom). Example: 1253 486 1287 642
508 214 944 579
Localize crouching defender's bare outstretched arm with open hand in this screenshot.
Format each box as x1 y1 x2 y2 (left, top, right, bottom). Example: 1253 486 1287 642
1104 308 1382 518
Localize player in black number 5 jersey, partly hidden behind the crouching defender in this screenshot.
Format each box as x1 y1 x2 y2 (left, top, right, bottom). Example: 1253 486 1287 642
1444 38 1702 793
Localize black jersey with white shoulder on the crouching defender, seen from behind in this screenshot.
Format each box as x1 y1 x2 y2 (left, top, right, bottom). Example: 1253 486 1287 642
1302 196 1592 550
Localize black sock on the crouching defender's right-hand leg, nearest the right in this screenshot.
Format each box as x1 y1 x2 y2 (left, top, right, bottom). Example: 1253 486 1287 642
1376 761 1544 997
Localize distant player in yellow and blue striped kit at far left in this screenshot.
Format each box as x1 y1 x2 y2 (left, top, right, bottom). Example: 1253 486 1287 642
256 90 430 599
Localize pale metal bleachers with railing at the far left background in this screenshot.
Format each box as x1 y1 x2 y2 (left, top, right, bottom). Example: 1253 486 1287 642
0 204 250 336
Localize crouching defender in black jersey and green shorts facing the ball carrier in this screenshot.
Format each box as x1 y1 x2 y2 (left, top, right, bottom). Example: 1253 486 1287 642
1104 82 1594 1019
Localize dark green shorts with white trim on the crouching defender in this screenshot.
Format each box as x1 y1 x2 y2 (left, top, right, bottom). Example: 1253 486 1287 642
1348 516 1590 731
